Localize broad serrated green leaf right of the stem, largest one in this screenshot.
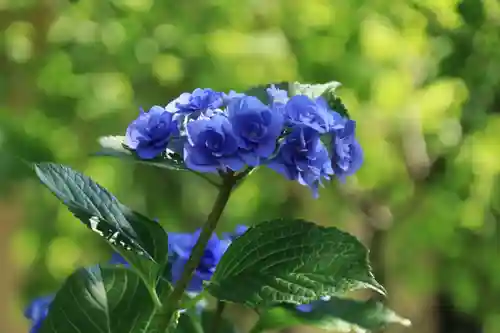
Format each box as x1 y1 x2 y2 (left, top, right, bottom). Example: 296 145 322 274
208 219 385 307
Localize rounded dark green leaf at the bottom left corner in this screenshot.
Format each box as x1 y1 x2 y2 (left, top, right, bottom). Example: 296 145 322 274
41 266 172 333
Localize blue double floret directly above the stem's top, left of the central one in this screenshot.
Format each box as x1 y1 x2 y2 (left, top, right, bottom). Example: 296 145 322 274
184 114 245 172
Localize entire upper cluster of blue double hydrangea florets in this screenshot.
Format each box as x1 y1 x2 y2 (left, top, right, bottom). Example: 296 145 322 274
125 85 363 197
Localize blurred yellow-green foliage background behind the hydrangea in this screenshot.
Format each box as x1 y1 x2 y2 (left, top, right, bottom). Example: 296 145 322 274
0 0 500 333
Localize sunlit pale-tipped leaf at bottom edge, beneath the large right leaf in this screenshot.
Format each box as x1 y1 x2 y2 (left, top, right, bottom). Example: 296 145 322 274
252 297 411 333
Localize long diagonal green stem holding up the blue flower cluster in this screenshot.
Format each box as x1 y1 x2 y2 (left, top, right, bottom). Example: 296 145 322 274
161 172 236 328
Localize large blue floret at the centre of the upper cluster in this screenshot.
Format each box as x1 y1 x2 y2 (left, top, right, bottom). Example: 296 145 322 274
227 96 284 166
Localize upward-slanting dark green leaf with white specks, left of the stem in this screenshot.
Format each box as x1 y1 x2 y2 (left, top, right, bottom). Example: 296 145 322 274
35 163 168 287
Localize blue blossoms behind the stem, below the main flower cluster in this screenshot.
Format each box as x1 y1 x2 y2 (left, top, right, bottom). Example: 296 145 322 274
168 230 230 292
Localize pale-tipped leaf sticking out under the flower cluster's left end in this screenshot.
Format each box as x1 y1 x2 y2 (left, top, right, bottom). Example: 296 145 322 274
95 136 187 170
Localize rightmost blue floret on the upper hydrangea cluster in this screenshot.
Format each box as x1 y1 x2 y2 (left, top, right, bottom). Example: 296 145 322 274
331 120 363 181
